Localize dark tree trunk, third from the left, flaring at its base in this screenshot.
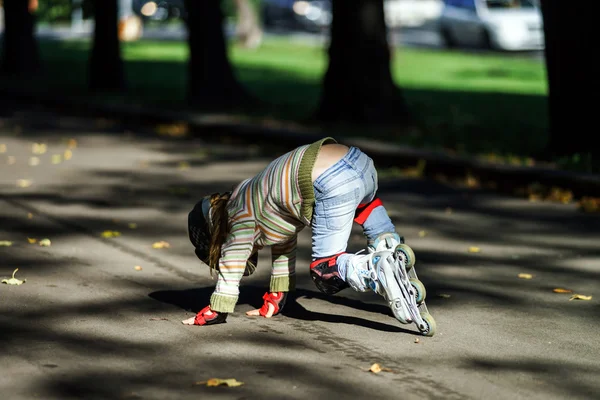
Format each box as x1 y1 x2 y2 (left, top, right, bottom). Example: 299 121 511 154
185 0 251 110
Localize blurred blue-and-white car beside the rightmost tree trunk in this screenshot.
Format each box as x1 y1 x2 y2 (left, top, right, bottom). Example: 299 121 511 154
439 0 544 51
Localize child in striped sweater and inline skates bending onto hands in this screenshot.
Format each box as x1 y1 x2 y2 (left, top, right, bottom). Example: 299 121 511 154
182 137 435 335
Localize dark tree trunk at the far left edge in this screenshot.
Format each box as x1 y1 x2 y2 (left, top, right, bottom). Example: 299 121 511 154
2 0 40 76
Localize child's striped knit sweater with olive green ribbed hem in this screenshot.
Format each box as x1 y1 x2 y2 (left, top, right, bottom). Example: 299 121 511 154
210 137 335 312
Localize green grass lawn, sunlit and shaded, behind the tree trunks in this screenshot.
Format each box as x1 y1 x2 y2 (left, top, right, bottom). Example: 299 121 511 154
0 39 547 162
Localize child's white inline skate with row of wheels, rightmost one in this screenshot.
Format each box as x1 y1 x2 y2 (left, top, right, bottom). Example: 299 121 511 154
369 233 436 336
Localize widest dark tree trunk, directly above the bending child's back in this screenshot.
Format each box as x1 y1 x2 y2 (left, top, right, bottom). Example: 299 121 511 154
317 0 409 123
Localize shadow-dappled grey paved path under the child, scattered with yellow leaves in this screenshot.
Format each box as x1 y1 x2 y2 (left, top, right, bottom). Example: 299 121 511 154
0 106 600 400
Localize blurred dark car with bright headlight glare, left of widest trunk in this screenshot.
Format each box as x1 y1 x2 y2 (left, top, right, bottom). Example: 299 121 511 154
261 0 332 32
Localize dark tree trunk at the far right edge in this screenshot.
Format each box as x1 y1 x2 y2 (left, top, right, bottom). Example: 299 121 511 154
541 0 600 157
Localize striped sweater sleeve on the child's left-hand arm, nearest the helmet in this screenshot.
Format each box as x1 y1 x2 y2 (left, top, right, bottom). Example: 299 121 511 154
210 220 256 313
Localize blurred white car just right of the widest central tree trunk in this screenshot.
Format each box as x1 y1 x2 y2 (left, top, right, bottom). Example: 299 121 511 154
384 0 444 28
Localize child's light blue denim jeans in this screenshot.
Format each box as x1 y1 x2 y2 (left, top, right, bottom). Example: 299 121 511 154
311 147 396 272
